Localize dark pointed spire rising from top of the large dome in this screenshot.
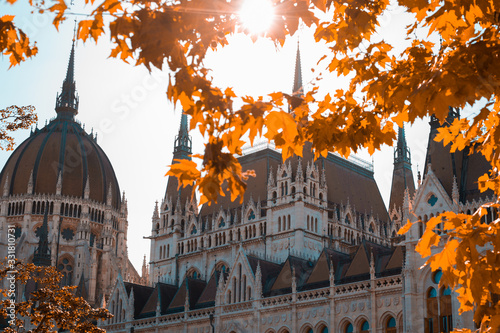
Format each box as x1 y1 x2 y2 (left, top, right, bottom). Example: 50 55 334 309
56 38 78 120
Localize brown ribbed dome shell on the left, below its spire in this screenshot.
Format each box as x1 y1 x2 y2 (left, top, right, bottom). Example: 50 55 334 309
0 116 120 209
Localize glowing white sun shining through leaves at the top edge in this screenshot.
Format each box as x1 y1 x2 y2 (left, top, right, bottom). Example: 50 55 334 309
239 0 274 35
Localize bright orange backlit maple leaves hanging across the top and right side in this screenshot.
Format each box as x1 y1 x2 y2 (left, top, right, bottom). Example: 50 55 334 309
0 0 500 332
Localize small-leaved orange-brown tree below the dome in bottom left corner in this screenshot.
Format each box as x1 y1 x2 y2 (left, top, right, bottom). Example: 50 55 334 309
0 260 112 333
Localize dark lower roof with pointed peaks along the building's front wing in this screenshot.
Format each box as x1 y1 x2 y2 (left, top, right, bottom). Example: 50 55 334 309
125 241 404 318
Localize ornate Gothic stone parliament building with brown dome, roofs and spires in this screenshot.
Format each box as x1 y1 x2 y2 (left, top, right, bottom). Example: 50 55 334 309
0 41 497 333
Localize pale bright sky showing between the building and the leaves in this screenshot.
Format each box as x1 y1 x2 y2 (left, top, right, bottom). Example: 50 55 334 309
0 3 429 272
